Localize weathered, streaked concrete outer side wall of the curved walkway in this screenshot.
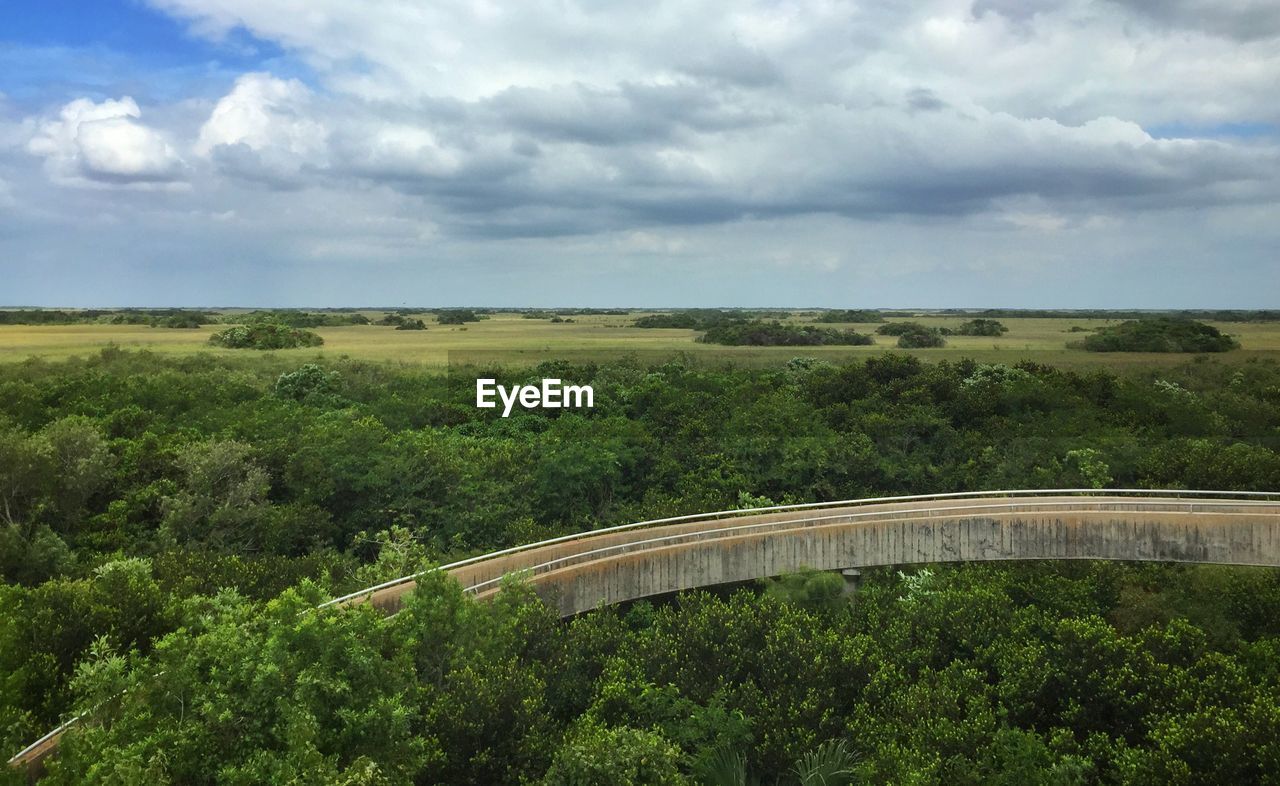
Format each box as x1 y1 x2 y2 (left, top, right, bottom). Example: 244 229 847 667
480 501 1280 616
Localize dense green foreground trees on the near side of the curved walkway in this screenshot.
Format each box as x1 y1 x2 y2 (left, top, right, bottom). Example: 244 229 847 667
32 563 1280 786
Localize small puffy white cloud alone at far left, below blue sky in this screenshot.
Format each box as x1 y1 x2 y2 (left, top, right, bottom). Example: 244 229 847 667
27 96 183 186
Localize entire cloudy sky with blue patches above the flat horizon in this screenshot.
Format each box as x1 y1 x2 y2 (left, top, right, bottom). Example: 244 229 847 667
0 0 1280 309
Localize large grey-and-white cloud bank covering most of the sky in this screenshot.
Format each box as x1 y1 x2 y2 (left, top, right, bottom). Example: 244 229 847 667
122 0 1280 234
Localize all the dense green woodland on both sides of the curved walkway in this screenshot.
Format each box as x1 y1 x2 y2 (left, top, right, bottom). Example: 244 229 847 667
0 349 1280 783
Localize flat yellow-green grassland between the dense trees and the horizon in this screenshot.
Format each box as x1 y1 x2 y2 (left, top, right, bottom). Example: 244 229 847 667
0 314 1280 367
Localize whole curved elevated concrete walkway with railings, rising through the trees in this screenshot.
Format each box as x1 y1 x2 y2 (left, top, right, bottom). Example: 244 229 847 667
9 489 1280 773
